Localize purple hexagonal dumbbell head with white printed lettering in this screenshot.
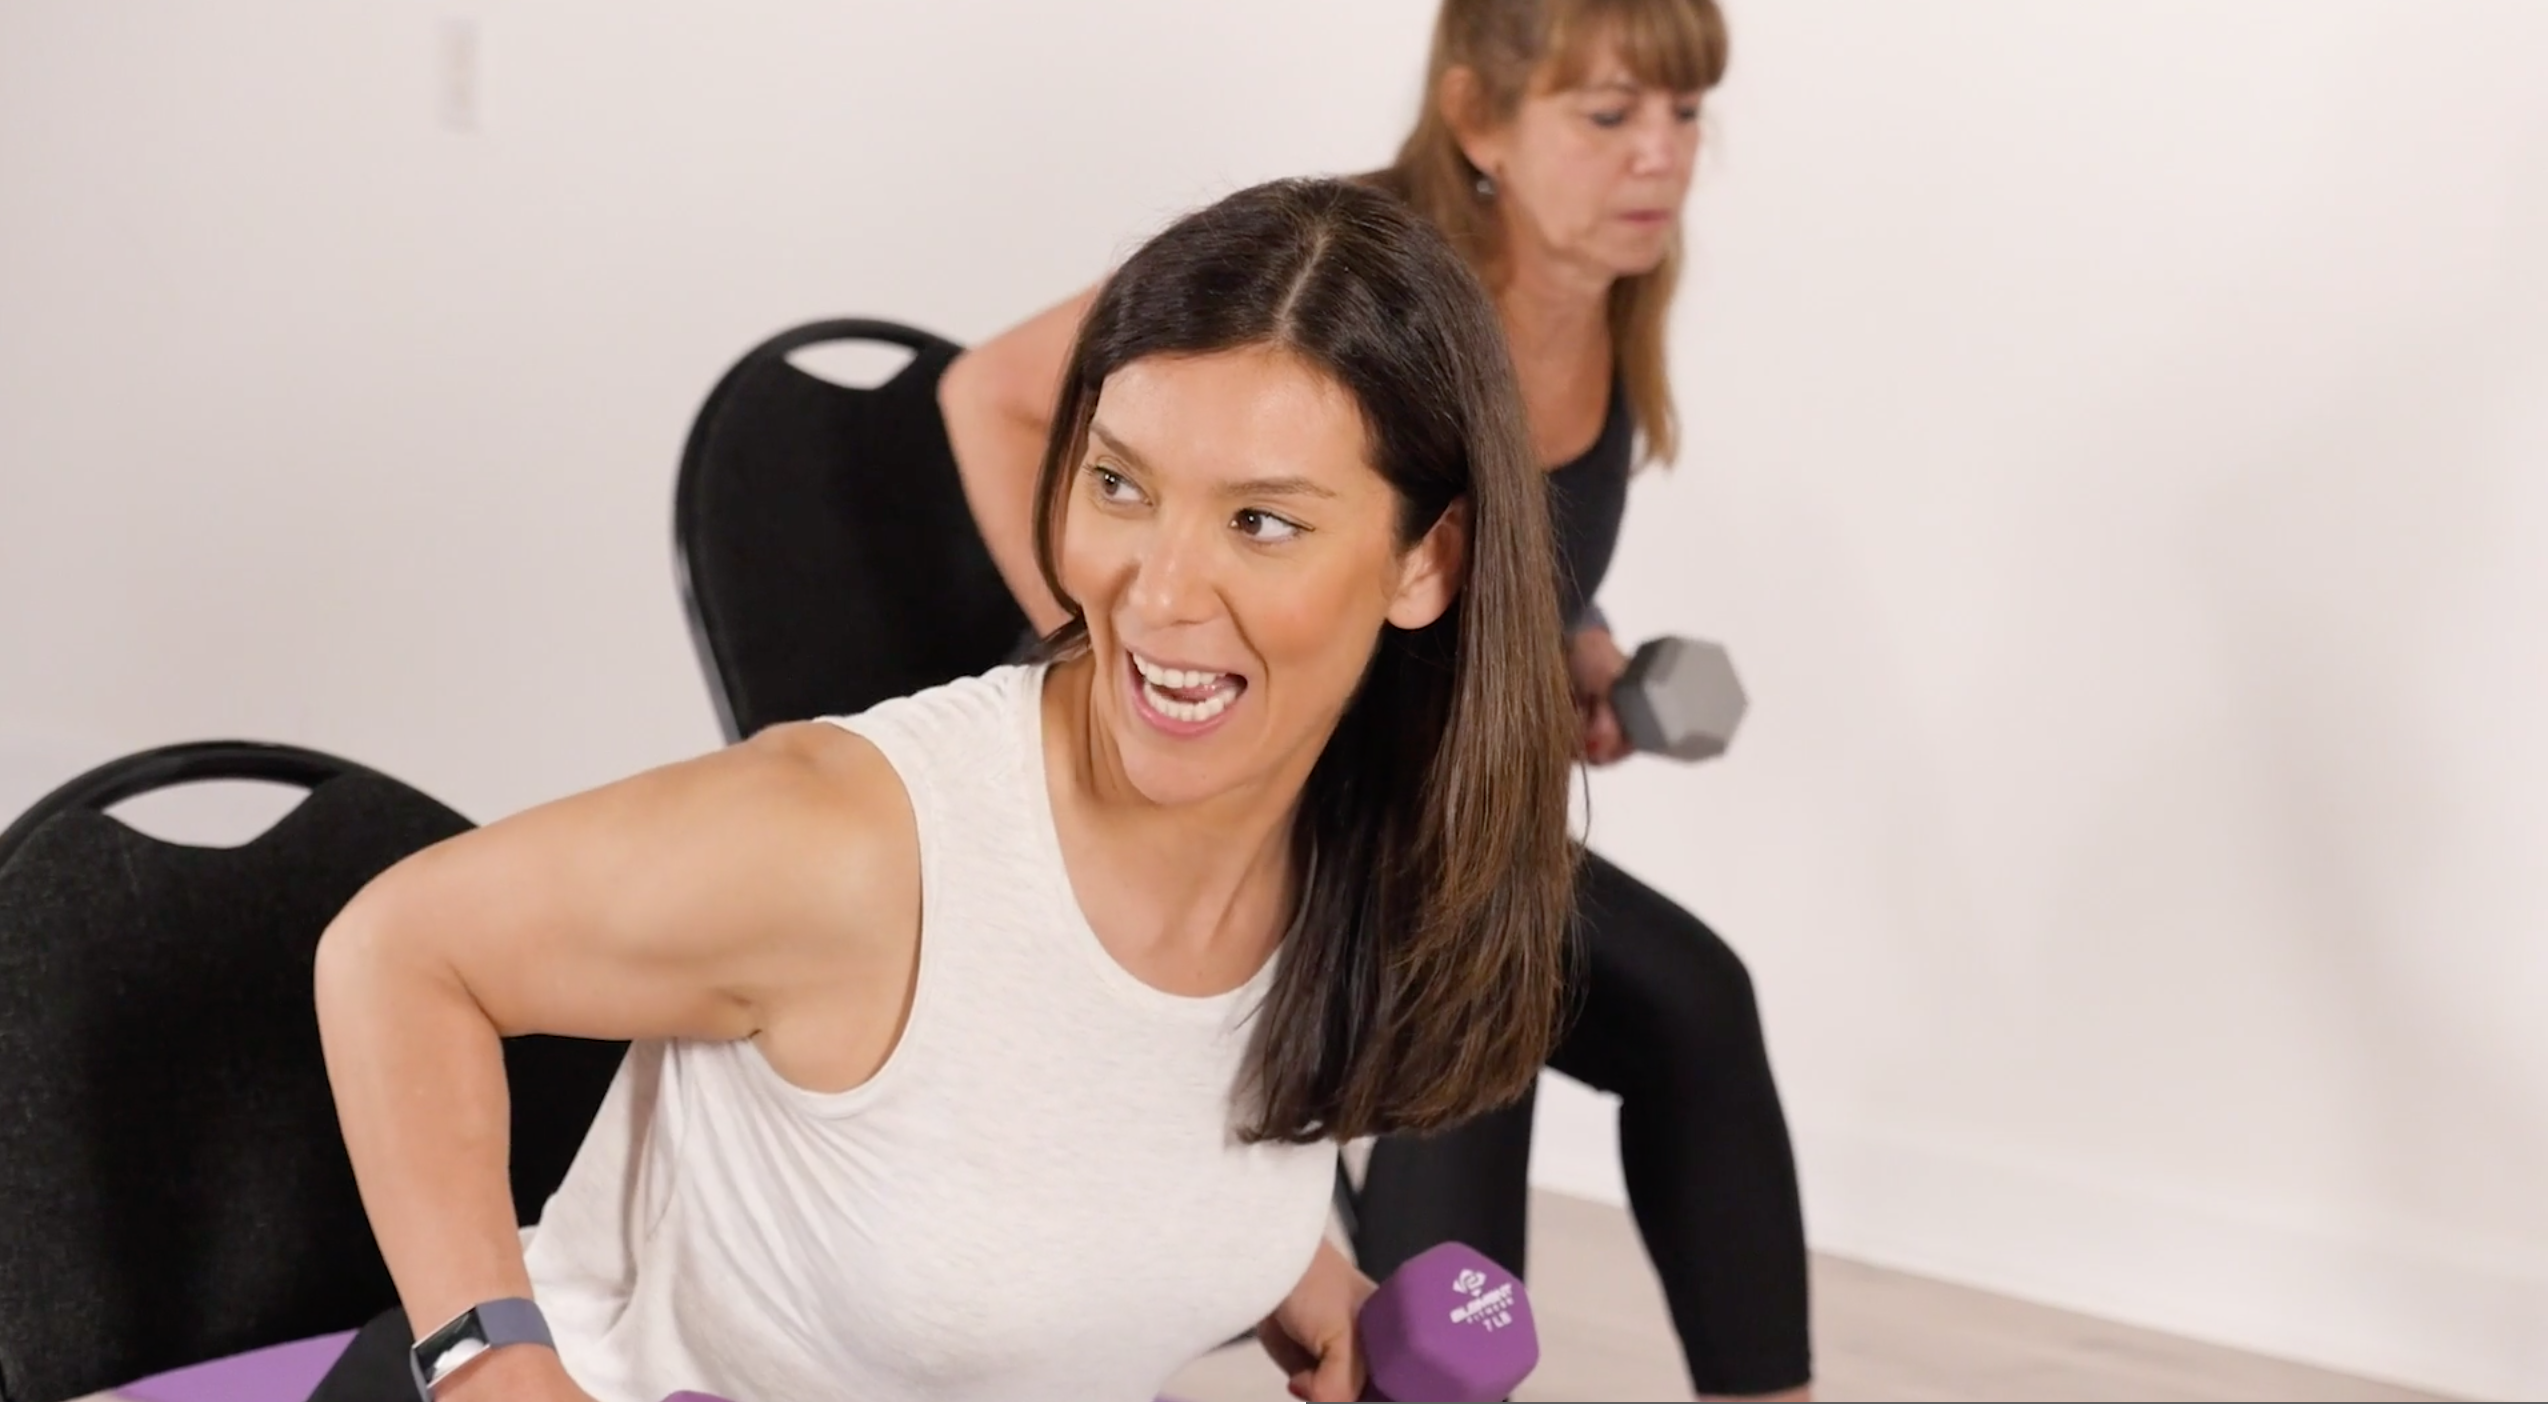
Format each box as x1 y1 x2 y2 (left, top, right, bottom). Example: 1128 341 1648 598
1361 1243 1539 1404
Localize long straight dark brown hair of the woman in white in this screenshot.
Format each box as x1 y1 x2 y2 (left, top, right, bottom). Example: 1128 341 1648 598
1034 181 1577 1142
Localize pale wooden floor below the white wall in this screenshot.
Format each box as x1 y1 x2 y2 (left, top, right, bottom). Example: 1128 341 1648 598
1167 1193 2436 1399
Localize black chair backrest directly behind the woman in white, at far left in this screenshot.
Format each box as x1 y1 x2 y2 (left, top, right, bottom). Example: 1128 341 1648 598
0 741 622 1399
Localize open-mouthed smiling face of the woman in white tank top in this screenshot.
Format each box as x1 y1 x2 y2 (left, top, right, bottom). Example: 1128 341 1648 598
1057 347 1465 805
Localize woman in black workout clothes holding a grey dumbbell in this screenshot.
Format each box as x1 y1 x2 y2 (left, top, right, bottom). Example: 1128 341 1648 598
940 0 1812 1396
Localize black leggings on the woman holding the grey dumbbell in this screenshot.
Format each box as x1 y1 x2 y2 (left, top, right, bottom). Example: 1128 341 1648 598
1356 851 1814 1394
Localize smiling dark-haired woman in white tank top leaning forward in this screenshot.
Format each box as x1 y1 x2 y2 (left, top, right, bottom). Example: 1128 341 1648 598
298 181 1575 1399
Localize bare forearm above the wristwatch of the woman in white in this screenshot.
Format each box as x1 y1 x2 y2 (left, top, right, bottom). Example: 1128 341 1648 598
316 899 530 1335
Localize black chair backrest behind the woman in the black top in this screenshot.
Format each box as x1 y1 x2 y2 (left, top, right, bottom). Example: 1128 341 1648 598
673 319 1027 739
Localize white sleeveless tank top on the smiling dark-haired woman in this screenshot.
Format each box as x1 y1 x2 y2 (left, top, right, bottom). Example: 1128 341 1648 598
525 668 1335 1399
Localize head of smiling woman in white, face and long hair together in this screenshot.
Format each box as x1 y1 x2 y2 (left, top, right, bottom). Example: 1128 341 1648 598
1034 181 1572 1139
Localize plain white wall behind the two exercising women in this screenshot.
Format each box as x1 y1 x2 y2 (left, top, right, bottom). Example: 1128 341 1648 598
0 0 2548 1396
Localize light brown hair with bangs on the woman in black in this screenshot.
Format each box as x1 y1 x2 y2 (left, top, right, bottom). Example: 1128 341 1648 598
1368 0 1728 461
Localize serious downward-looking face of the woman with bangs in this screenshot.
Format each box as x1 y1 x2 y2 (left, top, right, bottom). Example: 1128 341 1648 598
1463 46 1700 278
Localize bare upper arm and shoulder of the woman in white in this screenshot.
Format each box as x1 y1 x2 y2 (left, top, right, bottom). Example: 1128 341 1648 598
321 724 920 1060
